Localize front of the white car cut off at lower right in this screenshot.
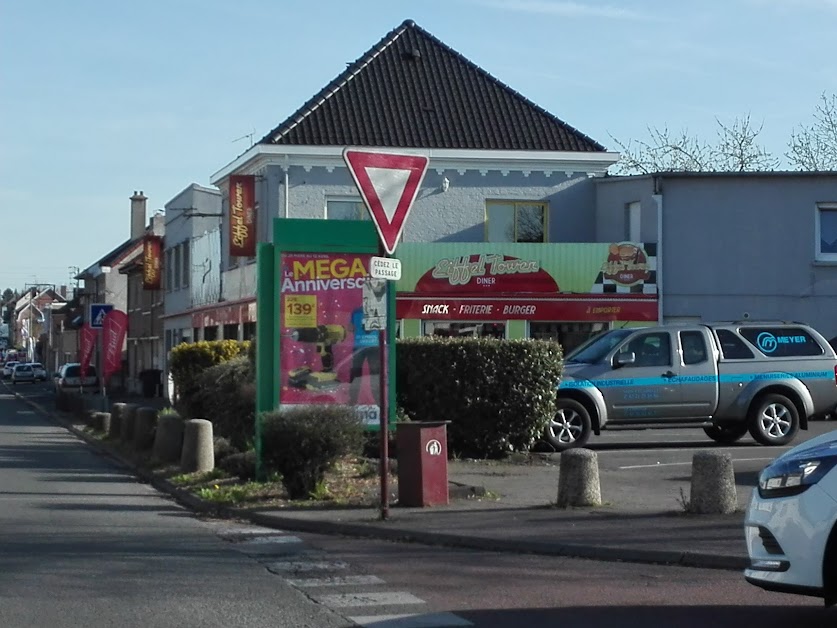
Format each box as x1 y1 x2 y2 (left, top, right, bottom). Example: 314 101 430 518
744 431 837 606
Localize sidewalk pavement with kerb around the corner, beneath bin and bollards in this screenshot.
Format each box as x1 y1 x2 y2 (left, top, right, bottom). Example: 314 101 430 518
7 388 749 570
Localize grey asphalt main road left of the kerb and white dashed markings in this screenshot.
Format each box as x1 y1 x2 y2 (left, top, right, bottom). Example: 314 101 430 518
0 388 352 628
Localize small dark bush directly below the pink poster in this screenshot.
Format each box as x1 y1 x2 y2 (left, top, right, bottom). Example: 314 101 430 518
262 405 364 499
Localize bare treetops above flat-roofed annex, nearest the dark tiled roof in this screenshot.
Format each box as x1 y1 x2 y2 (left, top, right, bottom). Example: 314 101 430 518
611 114 779 174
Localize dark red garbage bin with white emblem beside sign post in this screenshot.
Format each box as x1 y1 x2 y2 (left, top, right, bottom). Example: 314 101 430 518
396 421 449 507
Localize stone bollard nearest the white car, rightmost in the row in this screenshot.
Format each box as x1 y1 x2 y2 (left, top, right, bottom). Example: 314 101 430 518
688 451 738 515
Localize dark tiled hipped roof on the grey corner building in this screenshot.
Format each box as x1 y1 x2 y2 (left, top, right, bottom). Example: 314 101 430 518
259 20 605 152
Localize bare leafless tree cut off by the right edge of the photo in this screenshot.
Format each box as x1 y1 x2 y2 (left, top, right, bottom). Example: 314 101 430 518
786 92 837 170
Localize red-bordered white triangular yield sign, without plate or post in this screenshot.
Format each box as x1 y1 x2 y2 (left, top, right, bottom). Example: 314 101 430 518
343 148 430 255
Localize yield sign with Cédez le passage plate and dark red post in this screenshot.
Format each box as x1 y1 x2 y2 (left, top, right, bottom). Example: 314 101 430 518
343 147 430 519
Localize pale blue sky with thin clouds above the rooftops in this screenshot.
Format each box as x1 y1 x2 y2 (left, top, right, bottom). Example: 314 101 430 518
0 0 837 290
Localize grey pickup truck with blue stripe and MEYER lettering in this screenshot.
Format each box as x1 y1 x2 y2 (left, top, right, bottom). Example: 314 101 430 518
545 321 837 451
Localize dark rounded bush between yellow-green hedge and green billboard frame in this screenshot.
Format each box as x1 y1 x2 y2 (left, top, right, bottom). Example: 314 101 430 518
187 356 256 450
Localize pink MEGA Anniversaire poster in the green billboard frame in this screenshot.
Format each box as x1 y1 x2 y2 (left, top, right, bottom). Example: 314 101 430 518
279 253 386 425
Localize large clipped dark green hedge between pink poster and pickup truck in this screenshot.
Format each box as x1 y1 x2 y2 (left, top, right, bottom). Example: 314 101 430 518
396 337 563 458
